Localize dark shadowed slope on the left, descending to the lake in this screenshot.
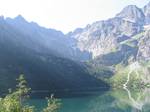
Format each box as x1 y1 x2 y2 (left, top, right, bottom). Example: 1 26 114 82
0 36 108 95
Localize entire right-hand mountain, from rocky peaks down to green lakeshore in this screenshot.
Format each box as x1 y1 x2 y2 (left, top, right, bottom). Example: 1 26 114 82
68 2 150 88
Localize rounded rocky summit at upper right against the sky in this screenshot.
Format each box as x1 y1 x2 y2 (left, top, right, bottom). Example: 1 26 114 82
116 5 145 25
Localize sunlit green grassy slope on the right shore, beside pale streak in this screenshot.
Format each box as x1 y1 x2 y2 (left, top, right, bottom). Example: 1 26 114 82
109 61 150 88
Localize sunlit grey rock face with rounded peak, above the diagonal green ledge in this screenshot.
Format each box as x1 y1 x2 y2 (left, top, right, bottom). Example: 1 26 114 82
69 6 144 58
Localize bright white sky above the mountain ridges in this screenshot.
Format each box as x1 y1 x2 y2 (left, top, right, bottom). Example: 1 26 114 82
0 0 150 33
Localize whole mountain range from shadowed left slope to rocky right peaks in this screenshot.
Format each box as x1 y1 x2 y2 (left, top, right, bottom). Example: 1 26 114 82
0 3 150 96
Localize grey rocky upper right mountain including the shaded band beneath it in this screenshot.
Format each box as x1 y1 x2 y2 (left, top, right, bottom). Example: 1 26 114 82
68 3 150 65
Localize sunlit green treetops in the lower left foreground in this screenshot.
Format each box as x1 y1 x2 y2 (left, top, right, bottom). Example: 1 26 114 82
0 75 61 112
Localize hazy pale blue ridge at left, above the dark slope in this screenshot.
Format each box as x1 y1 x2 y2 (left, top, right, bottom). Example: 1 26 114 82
5 15 90 60
